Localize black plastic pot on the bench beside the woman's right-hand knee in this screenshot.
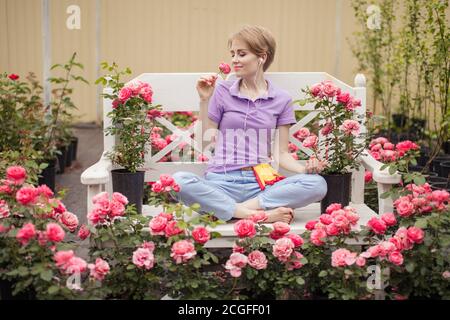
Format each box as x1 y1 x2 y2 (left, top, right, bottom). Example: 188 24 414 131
320 172 352 213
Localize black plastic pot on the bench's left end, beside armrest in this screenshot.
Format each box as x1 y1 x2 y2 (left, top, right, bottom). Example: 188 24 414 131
111 169 145 214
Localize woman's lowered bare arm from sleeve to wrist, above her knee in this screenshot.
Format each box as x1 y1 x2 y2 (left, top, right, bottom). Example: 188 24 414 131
273 125 306 173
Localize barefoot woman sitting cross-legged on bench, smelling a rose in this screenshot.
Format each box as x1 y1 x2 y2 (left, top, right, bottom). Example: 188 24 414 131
173 26 327 223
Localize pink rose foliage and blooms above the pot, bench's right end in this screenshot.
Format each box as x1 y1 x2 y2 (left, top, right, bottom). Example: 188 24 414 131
294 80 367 173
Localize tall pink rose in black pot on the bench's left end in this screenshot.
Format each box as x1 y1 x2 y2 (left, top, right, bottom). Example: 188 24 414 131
96 62 160 213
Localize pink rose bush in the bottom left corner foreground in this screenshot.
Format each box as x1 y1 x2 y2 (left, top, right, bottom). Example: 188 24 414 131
0 166 109 299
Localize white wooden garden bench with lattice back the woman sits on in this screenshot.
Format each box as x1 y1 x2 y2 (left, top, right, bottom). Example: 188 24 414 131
81 72 400 247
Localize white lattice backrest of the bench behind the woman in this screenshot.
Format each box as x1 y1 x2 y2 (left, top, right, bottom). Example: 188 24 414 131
103 72 366 203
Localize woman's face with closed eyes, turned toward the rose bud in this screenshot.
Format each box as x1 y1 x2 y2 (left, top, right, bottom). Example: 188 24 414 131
230 39 263 78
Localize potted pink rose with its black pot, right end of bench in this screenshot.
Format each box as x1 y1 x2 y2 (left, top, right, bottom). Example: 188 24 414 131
294 80 368 212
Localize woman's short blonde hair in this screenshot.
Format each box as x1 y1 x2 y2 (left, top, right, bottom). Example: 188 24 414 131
228 25 277 71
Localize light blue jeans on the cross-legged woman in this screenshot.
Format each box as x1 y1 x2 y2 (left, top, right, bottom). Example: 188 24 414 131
173 170 327 221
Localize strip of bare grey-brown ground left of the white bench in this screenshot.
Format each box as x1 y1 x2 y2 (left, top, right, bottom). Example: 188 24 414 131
56 126 103 223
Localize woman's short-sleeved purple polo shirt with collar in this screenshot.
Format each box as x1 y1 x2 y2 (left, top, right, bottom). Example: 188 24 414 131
205 78 296 174
